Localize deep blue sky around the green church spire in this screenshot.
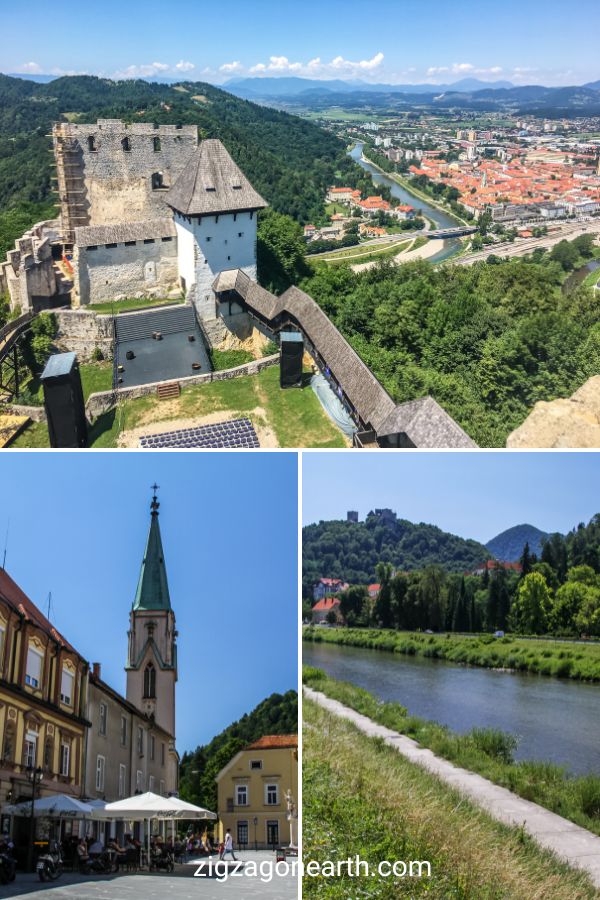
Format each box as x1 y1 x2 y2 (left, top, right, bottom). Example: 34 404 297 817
0 452 298 752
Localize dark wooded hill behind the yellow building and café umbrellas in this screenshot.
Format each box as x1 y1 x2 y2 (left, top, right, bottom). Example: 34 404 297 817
179 691 298 811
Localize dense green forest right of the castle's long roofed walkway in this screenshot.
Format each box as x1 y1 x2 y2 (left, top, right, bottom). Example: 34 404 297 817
302 235 600 447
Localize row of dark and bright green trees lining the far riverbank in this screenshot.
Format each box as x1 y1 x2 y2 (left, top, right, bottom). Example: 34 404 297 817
304 515 600 637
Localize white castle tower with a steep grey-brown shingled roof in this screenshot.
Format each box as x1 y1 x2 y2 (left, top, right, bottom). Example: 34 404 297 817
165 140 267 320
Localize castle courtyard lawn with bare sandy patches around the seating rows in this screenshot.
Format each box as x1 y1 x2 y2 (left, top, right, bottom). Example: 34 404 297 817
11 366 346 447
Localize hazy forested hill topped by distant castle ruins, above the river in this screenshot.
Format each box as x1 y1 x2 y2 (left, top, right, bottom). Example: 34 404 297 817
302 513 490 597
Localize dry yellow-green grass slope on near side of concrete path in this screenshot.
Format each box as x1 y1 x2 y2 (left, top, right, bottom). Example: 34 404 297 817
302 699 599 900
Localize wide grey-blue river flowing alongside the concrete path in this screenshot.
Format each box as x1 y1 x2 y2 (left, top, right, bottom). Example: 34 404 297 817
302 641 600 775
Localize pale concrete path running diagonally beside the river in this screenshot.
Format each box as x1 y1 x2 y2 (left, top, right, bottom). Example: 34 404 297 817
304 687 600 888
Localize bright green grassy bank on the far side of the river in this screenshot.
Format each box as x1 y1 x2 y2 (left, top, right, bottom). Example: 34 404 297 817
302 626 600 682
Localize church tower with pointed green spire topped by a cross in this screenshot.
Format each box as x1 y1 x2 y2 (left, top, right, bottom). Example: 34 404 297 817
125 485 177 737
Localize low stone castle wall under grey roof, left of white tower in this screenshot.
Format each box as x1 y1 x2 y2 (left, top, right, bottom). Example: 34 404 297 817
73 238 180 306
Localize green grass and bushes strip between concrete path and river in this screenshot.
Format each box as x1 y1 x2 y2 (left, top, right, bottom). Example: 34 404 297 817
302 666 600 835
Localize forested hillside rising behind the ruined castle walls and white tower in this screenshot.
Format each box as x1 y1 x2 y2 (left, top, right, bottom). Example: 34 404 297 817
0 75 356 253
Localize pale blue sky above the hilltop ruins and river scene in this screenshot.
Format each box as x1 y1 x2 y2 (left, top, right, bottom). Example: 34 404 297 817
302 451 600 543
